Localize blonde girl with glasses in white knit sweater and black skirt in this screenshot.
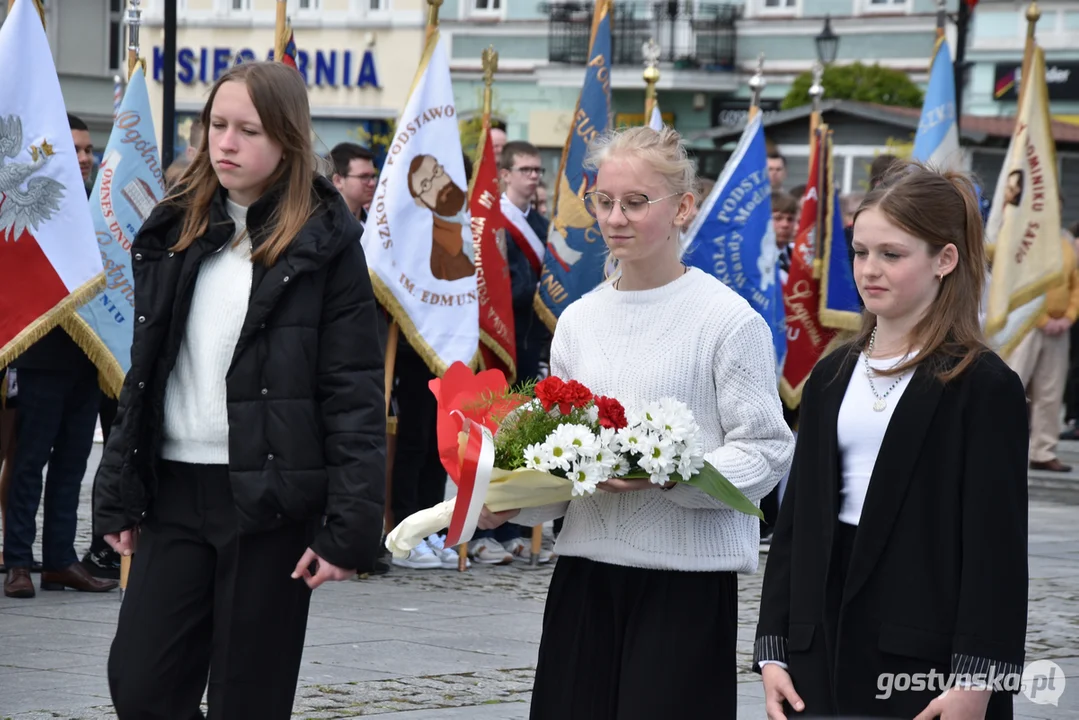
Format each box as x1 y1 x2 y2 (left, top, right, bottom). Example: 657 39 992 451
480 127 794 720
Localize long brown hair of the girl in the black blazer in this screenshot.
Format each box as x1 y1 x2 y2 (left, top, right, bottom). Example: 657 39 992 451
850 162 986 382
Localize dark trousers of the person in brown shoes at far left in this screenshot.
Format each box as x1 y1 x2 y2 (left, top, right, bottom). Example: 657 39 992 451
3 362 100 570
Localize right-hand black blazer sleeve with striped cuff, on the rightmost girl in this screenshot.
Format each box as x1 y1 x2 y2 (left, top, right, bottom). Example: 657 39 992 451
952 355 1028 676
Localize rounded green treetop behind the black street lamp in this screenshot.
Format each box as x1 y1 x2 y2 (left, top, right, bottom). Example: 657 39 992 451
782 63 925 110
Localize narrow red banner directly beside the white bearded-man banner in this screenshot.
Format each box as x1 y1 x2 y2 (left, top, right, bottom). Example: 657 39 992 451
468 130 517 382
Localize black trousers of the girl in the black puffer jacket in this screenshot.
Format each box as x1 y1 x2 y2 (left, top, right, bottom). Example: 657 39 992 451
108 461 316 720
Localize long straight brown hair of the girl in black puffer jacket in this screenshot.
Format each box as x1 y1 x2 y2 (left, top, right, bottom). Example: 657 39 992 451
164 63 316 266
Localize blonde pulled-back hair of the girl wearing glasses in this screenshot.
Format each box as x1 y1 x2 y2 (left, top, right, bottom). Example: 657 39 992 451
584 125 698 282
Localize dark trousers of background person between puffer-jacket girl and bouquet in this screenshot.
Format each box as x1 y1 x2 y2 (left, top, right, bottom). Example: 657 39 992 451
391 336 446 524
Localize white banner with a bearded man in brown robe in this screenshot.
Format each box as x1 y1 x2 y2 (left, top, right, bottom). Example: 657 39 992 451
363 31 479 376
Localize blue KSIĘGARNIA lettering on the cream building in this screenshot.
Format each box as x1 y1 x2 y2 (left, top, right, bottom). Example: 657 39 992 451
153 46 379 87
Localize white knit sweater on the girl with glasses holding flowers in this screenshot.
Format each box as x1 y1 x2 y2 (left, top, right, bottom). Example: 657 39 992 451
513 268 794 572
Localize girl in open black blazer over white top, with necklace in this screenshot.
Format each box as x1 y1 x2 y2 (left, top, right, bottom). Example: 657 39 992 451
753 164 1027 720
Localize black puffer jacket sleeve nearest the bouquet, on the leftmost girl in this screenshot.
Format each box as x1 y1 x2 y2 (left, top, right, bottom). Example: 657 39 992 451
312 241 386 572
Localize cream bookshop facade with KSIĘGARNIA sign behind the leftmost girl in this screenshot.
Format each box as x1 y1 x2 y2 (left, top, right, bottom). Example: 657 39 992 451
141 0 426 165
